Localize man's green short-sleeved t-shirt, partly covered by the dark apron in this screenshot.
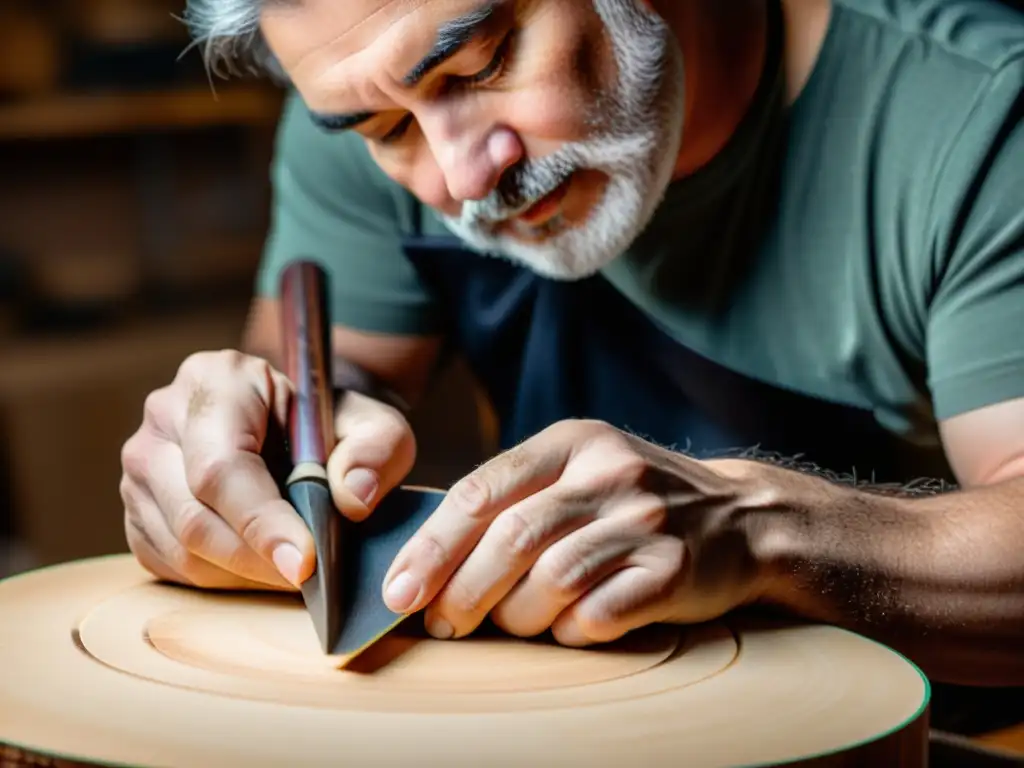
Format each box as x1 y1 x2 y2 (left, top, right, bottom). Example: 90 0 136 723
258 0 1024 445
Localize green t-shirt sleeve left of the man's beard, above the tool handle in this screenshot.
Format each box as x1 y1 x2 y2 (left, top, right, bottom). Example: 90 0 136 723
256 92 439 336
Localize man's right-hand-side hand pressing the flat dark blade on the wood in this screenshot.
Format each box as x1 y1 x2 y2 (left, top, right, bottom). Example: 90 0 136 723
384 421 766 646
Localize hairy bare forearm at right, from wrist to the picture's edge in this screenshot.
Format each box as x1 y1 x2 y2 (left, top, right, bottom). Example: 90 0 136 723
733 460 1024 685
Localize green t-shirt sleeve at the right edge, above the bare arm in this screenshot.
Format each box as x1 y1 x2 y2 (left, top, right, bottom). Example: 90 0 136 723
927 65 1024 420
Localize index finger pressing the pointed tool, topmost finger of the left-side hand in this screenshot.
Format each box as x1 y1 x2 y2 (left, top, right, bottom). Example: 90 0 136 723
180 378 315 583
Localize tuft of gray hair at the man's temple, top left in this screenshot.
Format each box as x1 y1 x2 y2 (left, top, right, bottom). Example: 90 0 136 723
181 0 290 81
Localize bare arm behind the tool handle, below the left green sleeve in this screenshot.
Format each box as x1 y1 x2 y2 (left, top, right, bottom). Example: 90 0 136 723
243 298 441 406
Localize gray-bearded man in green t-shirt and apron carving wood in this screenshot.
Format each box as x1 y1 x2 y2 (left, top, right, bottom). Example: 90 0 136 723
122 0 1024 685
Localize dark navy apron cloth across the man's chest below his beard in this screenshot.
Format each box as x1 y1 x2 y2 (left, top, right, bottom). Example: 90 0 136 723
404 237 951 482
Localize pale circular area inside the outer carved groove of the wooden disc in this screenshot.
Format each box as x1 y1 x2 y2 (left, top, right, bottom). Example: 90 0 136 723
78 584 737 712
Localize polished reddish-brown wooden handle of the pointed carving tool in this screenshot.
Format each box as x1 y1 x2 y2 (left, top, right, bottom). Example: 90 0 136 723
282 261 335 467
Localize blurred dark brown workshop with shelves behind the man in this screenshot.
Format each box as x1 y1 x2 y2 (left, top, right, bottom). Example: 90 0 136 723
0 0 489 578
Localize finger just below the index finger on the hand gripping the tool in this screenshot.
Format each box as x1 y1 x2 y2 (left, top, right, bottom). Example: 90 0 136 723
150 441 302 589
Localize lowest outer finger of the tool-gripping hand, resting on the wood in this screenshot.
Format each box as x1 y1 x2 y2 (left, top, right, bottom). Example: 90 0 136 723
125 483 282 590
